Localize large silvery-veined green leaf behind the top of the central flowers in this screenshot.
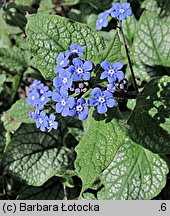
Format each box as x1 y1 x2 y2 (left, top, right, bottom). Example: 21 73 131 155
26 14 105 79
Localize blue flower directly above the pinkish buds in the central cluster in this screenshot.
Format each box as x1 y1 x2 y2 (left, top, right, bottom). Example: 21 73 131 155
72 58 93 81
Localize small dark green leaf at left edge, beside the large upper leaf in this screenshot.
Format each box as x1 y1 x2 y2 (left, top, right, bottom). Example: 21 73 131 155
0 47 27 72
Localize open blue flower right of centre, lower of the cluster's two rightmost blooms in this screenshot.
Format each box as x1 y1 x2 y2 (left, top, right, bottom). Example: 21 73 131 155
88 87 116 114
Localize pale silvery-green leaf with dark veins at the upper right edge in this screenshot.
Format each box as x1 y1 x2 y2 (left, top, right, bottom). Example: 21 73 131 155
133 12 170 76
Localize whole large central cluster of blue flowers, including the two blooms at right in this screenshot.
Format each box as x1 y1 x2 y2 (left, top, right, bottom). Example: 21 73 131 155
28 44 124 131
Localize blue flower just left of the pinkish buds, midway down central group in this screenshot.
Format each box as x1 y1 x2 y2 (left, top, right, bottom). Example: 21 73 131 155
53 70 73 89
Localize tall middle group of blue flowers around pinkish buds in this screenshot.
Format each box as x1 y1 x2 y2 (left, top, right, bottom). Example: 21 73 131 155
52 44 93 120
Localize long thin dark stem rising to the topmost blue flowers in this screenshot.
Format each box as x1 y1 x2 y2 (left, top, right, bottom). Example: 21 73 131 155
119 20 138 93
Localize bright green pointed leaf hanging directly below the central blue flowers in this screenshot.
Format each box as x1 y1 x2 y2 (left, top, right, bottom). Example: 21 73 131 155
75 110 124 191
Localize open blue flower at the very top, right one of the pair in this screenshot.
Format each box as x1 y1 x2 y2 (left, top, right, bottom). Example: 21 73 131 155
111 2 132 20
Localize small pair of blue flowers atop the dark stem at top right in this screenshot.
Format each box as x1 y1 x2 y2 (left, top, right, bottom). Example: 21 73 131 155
96 2 132 30
